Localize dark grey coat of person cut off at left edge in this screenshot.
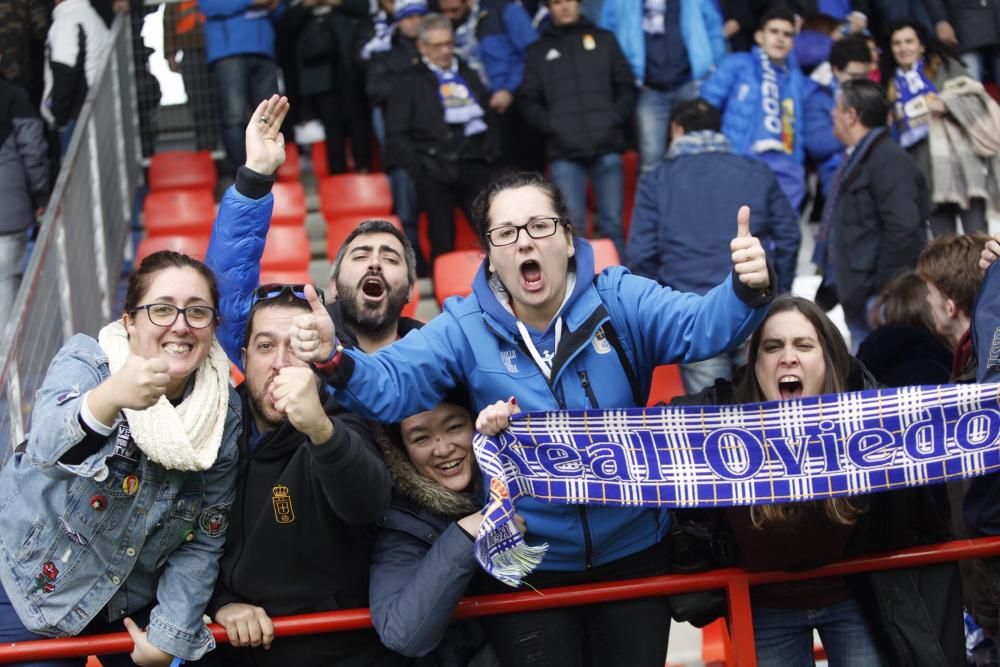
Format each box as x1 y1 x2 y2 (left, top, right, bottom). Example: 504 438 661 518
0 78 49 234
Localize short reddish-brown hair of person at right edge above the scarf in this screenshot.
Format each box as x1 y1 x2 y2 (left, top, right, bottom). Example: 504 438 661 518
917 232 990 316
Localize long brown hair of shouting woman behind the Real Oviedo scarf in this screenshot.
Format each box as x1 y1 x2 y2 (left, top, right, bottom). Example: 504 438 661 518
736 295 860 528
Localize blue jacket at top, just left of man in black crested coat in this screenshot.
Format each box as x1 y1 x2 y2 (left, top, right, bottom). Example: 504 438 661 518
476 0 538 93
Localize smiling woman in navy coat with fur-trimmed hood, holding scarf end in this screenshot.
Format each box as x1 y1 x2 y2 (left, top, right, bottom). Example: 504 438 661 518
369 391 497 667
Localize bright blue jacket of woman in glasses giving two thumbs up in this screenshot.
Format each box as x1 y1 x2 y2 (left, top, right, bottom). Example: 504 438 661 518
327 239 764 571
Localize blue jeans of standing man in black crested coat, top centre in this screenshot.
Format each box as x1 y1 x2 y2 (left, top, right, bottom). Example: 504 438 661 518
549 153 625 258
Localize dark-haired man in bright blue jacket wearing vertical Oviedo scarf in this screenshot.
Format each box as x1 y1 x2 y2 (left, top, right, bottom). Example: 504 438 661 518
701 7 806 209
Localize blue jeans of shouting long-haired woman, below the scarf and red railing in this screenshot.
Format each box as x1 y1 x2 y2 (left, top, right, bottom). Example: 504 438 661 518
753 600 883 667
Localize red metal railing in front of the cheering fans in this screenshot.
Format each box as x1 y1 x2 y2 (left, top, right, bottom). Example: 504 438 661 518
0 537 1000 667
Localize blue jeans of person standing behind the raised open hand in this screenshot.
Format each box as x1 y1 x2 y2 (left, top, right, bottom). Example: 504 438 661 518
212 54 278 169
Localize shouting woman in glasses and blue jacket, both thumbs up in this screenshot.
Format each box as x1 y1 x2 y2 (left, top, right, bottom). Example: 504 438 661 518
292 173 772 667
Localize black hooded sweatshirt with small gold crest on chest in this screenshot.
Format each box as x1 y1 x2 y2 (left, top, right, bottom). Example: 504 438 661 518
207 383 400 667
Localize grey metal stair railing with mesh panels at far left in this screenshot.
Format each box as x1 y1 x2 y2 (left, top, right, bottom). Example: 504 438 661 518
0 16 141 463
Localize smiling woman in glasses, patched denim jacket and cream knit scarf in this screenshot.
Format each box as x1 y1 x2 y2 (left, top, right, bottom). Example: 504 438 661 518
0 251 240 666
